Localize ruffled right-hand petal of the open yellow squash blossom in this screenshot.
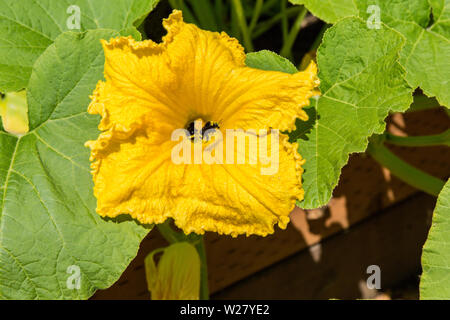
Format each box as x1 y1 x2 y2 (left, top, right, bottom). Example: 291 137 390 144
215 62 318 131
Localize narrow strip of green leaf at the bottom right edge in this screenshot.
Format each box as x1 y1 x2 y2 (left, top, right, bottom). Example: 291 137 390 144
420 180 450 300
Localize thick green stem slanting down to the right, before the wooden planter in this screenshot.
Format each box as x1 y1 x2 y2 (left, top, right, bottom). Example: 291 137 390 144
367 137 445 197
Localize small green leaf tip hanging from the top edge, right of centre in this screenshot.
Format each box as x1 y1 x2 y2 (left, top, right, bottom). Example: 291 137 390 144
289 0 358 23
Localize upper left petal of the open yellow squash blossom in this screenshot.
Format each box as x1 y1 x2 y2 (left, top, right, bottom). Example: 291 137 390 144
88 13 188 130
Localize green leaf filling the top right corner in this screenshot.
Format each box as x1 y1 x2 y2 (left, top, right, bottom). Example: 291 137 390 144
357 0 450 107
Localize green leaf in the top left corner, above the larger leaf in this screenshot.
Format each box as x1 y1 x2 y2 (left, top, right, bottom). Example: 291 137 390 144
0 0 159 92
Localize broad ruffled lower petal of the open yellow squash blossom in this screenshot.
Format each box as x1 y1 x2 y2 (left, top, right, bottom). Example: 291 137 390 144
87 129 304 236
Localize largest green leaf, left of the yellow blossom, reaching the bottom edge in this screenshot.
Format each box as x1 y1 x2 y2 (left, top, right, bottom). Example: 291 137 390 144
0 29 148 299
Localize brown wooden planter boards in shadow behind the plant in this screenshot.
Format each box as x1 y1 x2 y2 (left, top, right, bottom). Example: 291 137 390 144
93 109 450 299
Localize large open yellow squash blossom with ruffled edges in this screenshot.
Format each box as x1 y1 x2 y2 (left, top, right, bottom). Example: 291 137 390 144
87 11 317 236
